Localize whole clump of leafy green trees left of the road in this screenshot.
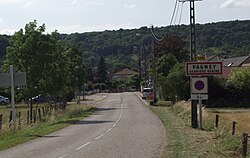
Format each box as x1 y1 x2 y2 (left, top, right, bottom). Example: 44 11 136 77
2 21 89 108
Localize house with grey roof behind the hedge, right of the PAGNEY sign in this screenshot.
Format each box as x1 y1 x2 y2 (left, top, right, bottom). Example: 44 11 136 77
207 55 250 78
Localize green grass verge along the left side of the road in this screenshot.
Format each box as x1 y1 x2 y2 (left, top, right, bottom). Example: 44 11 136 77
0 104 95 150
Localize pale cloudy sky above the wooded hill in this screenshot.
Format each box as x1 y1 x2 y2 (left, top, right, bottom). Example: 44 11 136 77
0 0 250 35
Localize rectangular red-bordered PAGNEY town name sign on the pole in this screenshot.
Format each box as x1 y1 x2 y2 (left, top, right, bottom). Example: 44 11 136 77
186 62 222 76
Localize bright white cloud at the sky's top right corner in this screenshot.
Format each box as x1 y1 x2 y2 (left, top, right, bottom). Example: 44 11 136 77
220 0 250 9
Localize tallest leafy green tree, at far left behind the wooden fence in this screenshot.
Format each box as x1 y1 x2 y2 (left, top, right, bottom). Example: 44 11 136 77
3 21 67 106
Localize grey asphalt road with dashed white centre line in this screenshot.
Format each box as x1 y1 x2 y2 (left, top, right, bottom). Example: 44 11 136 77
0 92 164 158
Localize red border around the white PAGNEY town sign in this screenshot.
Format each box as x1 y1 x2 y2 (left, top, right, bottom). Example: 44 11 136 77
186 62 222 76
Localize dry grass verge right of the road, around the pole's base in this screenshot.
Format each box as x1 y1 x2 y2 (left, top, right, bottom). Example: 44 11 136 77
150 100 240 158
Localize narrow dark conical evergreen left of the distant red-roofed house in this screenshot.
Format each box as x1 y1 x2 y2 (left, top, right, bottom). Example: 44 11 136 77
97 57 108 83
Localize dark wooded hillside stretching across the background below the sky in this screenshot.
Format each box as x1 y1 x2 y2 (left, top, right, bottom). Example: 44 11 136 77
0 20 250 72
